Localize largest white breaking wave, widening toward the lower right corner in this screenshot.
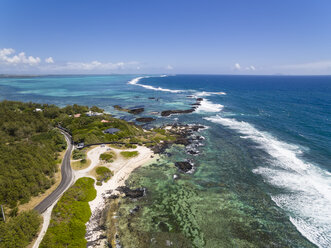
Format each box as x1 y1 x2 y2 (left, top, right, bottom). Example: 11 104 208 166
205 116 331 248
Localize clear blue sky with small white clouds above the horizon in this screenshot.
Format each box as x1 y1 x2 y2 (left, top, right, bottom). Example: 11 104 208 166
0 0 331 74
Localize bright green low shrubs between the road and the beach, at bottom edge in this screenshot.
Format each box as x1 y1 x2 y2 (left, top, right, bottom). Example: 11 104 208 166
40 177 96 248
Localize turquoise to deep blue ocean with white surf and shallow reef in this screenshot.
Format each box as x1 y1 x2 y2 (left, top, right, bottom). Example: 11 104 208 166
0 75 331 247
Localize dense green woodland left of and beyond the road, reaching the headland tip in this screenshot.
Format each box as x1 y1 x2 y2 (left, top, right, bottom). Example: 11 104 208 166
0 101 173 208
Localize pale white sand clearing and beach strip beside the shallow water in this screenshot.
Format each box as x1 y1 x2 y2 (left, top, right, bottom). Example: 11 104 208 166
80 146 157 247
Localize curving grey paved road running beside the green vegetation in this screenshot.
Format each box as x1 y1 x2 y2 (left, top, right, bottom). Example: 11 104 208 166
34 131 73 213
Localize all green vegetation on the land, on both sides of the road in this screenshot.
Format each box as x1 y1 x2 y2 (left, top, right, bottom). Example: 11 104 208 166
0 101 179 248
